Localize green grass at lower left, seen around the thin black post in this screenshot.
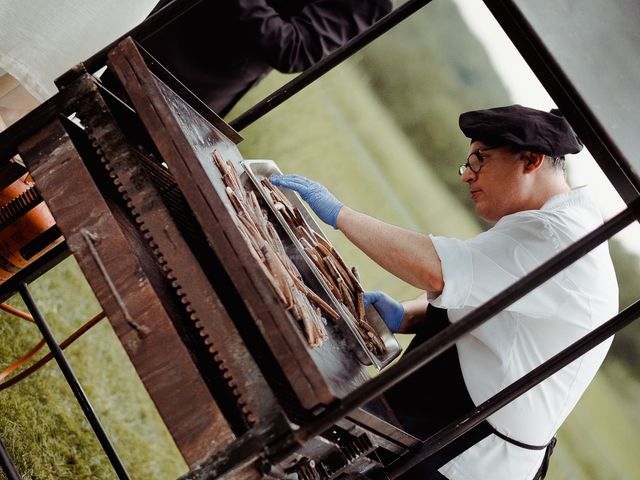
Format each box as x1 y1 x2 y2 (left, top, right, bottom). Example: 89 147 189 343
0 259 186 480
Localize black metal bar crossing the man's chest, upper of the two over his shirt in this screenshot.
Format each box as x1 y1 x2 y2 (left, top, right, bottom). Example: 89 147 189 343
296 201 640 443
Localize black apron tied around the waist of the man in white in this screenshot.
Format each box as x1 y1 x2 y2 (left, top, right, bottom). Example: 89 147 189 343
384 305 556 480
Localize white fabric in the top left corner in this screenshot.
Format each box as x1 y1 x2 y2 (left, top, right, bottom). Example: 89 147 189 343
0 0 158 101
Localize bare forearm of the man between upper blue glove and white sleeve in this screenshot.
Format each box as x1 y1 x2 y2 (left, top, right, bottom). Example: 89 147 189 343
336 206 444 292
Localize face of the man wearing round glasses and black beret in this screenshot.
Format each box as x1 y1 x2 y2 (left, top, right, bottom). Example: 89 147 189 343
461 141 525 222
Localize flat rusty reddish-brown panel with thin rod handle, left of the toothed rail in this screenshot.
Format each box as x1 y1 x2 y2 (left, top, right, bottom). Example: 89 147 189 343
19 121 234 465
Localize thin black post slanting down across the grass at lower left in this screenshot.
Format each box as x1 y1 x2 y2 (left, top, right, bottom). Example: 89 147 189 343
18 283 129 480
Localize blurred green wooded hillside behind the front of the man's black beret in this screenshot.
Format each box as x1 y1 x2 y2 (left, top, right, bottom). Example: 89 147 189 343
358 0 511 214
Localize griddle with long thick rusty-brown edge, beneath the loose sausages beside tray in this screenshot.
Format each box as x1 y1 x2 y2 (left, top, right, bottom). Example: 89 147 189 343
109 40 367 408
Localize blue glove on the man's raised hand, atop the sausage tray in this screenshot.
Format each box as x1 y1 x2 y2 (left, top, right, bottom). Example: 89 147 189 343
269 175 343 228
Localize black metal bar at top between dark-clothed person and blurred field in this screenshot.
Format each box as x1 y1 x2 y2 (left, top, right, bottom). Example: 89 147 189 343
229 0 431 131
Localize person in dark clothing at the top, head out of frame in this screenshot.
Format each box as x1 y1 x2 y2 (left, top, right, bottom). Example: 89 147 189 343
142 0 392 115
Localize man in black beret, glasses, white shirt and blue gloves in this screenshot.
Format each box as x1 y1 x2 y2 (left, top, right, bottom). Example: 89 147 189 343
272 105 618 480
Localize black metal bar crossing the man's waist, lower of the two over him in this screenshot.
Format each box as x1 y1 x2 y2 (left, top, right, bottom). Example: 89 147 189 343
374 300 640 479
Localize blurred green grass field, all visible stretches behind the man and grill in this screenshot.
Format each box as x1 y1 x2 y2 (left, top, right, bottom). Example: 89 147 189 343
0 21 640 480
